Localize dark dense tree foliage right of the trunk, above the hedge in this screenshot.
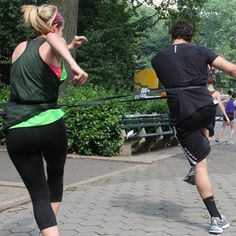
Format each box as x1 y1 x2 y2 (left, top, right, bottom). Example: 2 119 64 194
78 0 155 91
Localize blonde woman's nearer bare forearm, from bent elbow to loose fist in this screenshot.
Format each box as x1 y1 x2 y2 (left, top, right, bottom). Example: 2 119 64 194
46 33 88 85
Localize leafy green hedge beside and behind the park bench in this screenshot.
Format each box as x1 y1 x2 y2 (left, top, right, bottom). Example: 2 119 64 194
60 86 167 156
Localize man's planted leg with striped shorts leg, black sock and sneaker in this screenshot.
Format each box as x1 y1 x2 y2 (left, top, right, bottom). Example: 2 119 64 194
176 125 229 234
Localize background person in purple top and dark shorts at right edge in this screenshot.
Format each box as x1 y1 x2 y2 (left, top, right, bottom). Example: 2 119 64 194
215 92 236 144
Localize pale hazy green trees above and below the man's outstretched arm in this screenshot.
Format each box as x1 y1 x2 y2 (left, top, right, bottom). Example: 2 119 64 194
195 0 236 88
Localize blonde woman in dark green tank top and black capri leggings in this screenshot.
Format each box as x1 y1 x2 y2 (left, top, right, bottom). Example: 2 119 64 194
4 4 88 236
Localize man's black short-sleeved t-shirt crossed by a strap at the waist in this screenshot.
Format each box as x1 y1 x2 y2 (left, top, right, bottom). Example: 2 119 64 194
152 43 218 125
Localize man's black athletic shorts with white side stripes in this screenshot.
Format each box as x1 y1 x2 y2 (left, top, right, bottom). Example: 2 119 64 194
174 104 217 165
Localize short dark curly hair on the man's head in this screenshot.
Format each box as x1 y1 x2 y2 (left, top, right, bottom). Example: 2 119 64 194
171 20 193 43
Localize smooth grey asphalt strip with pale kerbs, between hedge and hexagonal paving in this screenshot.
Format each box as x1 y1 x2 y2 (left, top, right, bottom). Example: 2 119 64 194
0 147 181 213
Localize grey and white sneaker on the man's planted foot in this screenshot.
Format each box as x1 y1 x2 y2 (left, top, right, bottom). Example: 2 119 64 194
208 215 230 234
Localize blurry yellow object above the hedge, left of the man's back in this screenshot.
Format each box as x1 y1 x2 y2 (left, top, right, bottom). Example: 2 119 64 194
134 69 159 89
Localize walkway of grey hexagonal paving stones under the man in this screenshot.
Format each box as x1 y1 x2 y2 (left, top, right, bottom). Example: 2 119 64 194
0 122 236 236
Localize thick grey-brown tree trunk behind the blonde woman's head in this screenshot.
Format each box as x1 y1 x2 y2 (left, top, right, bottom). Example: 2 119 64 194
48 0 79 84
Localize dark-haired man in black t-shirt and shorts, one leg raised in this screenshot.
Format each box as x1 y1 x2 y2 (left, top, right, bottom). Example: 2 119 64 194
152 21 236 234
